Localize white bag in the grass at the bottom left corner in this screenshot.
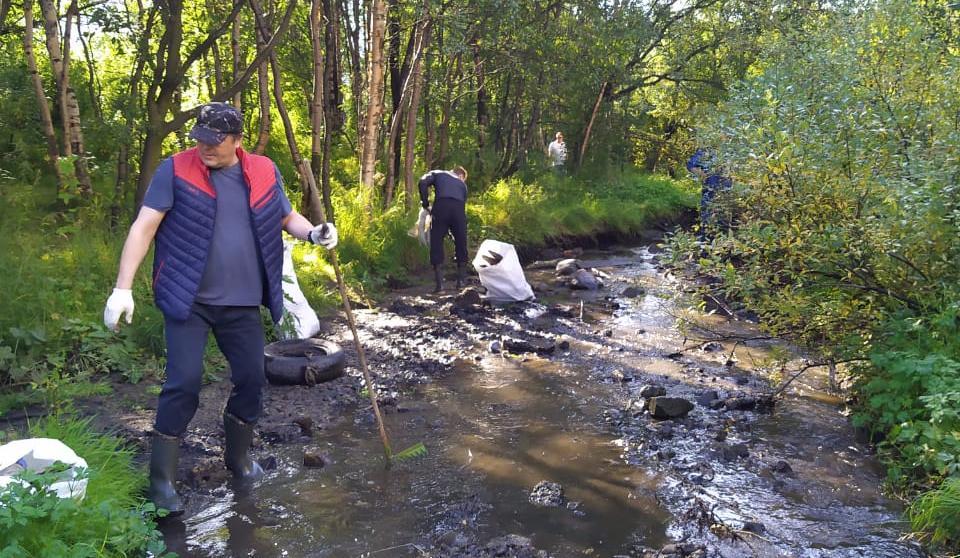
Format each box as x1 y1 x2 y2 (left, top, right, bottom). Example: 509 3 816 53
0 438 87 500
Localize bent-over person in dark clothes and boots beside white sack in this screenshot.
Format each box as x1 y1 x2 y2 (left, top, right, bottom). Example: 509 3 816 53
418 166 467 293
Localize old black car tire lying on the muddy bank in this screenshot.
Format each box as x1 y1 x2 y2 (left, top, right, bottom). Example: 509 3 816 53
263 338 346 386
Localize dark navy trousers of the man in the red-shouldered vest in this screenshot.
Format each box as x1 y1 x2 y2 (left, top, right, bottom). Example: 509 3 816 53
154 303 267 436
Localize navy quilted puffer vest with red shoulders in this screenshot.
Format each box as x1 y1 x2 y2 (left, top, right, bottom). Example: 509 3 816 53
153 148 284 322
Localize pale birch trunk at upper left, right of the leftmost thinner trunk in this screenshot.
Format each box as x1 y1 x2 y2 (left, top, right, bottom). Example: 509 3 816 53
40 0 93 195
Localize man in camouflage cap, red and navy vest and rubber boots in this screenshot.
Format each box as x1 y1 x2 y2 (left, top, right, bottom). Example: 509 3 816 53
103 103 337 515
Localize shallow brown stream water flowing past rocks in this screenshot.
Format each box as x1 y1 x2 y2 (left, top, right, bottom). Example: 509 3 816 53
164 247 922 558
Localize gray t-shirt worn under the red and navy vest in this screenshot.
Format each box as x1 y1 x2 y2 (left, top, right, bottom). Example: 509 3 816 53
143 164 292 306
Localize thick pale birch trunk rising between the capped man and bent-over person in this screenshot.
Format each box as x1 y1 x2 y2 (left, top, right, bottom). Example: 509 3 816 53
360 0 387 189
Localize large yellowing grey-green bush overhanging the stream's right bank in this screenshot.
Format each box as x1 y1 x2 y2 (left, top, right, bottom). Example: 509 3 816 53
688 1 960 350
